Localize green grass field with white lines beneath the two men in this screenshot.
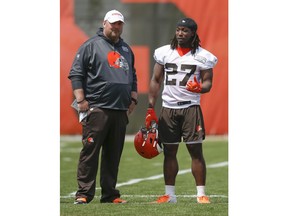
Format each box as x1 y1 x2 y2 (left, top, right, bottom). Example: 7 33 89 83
60 137 228 216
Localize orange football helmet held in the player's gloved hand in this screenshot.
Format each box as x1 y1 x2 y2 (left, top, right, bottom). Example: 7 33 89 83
134 127 163 159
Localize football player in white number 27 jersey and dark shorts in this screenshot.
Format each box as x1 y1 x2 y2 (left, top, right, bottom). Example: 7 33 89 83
146 18 217 203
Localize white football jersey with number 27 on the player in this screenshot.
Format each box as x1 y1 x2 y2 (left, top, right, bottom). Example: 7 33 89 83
154 45 218 109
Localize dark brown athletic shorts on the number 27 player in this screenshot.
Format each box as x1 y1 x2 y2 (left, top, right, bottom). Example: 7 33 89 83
158 105 205 144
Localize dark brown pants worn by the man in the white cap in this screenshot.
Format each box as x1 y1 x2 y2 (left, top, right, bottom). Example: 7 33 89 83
76 108 128 202
